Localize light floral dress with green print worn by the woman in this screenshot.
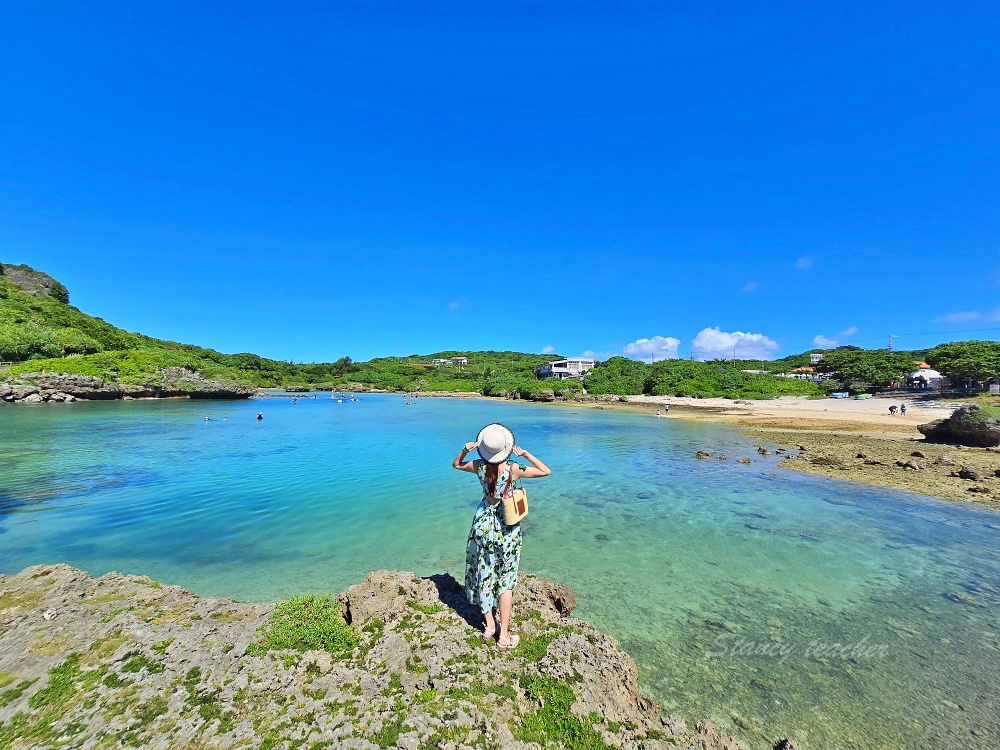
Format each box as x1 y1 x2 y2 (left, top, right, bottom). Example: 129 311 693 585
465 459 521 612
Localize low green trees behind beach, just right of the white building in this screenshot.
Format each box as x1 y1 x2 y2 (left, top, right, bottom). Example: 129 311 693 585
583 357 822 398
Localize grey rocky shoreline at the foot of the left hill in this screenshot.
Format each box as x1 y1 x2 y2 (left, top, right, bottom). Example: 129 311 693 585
0 367 257 404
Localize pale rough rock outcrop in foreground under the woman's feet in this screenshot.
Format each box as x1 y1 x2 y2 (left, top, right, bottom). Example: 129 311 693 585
0 565 795 750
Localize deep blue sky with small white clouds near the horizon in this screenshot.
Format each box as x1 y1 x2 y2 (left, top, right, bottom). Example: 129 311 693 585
0 0 1000 361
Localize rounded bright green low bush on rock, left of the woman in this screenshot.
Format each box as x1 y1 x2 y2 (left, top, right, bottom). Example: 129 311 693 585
247 595 361 656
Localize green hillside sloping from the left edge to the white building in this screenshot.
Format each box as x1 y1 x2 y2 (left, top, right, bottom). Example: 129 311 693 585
0 264 552 395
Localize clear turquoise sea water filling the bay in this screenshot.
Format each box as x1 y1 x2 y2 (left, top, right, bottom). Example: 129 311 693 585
0 395 1000 750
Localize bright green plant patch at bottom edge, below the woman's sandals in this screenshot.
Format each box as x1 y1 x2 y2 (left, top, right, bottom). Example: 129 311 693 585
515 675 608 750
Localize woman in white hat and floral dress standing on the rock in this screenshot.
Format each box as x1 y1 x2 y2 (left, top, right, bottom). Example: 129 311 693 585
451 424 552 649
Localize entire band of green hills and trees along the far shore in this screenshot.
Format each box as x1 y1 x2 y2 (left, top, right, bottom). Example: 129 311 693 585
7 264 1000 398
